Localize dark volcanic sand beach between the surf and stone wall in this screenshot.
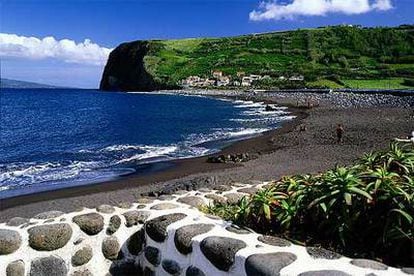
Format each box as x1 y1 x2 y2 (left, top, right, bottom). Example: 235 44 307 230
0 90 414 221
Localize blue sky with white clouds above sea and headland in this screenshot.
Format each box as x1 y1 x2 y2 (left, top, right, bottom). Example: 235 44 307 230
0 0 414 88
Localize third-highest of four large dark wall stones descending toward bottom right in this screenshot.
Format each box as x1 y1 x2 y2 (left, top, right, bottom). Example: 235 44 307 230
200 236 246 271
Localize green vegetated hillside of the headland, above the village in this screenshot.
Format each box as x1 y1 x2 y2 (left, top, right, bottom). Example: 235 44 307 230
145 27 414 88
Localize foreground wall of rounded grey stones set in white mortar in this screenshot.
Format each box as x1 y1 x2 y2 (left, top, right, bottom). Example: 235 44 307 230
0 183 414 276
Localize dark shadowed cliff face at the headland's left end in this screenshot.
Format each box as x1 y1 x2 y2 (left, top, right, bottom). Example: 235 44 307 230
99 41 163 91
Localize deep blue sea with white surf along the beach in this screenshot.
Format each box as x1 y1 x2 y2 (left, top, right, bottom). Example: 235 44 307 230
0 89 292 198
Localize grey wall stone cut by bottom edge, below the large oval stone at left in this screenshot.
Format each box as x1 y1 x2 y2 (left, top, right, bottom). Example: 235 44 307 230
30 256 68 276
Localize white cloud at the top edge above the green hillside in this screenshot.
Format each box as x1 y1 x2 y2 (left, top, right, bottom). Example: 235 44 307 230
249 0 393 21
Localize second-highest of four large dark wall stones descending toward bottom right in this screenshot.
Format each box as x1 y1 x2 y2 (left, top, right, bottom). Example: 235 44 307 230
174 224 214 255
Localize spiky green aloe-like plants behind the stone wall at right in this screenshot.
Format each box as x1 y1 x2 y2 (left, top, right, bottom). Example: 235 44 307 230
205 143 414 265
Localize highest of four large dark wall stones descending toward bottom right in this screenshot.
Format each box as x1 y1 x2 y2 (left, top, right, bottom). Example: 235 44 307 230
145 213 187 242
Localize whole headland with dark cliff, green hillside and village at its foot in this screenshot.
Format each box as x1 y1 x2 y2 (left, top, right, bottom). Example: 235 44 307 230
100 25 414 91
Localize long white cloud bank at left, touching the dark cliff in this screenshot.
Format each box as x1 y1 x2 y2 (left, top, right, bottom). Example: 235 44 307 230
0 33 112 65
